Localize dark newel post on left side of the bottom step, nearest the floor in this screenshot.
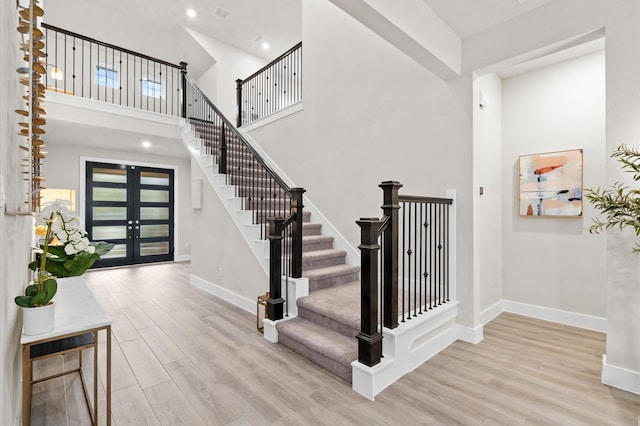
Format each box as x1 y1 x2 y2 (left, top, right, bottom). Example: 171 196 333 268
267 217 284 321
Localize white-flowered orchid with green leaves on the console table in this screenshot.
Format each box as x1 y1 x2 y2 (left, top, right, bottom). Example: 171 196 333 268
15 201 113 308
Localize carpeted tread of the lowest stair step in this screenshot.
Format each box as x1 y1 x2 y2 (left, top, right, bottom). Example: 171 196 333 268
277 317 358 365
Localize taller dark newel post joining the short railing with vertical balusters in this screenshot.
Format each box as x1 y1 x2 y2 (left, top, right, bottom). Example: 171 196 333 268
379 181 402 328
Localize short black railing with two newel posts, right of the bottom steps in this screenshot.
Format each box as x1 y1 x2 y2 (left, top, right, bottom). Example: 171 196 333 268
357 181 453 367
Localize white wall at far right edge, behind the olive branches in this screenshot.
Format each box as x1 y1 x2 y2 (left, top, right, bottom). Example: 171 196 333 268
606 0 640 380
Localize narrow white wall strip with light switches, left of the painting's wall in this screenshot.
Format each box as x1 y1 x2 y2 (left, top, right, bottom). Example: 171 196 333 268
473 73 503 323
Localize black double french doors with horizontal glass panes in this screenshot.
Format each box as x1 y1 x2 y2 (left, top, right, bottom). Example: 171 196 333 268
85 162 174 267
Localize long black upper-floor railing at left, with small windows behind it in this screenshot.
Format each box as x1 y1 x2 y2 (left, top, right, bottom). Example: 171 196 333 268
42 23 187 116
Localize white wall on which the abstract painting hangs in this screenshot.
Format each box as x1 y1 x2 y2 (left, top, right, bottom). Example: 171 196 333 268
502 51 607 318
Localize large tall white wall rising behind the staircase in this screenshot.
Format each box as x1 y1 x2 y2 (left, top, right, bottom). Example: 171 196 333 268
251 0 473 324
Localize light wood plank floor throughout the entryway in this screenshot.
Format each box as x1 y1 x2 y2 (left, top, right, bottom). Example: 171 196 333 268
32 263 640 426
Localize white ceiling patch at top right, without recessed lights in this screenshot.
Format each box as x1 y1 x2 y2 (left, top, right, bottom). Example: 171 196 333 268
423 0 553 38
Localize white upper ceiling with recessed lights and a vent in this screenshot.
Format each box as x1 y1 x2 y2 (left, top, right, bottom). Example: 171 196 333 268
83 0 302 60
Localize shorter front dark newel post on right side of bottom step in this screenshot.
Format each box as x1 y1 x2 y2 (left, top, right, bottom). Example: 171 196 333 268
356 218 382 367
